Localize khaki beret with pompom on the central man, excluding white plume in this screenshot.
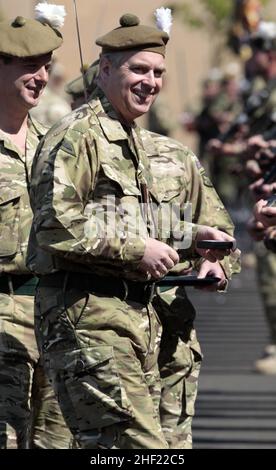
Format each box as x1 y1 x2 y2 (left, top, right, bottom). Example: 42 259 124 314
96 13 169 56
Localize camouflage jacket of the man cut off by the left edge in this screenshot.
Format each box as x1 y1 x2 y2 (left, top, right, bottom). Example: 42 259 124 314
0 118 46 274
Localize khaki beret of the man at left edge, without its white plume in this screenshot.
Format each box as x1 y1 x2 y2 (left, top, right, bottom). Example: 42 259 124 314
0 16 62 58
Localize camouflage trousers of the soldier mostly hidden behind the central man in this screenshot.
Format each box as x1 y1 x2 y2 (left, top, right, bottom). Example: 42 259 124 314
153 288 202 449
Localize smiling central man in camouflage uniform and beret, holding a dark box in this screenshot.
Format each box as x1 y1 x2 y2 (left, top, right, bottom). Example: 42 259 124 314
28 15 236 449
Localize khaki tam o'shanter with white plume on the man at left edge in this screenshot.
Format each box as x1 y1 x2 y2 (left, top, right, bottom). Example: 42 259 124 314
0 2 66 58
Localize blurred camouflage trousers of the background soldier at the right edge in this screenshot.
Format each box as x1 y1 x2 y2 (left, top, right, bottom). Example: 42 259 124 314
257 245 276 344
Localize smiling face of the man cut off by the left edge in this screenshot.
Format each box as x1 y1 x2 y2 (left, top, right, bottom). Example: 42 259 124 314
0 53 52 110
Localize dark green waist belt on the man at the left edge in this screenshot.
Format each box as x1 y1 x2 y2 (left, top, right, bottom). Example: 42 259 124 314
0 273 38 296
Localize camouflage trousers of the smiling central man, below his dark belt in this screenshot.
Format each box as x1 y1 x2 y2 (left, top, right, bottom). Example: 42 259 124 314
35 278 168 449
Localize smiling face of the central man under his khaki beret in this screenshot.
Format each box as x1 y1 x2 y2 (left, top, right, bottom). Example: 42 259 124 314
104 51 165 123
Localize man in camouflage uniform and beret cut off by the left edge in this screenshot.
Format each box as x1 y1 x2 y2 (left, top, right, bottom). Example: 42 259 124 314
0 7 70 448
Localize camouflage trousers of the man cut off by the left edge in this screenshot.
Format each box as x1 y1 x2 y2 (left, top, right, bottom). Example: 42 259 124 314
0 294 72 449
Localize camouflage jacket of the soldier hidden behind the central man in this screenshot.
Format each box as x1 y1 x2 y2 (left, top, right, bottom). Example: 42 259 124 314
141 130 240 279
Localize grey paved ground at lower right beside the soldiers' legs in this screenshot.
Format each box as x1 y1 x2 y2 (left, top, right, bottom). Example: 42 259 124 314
190 269 276 449
